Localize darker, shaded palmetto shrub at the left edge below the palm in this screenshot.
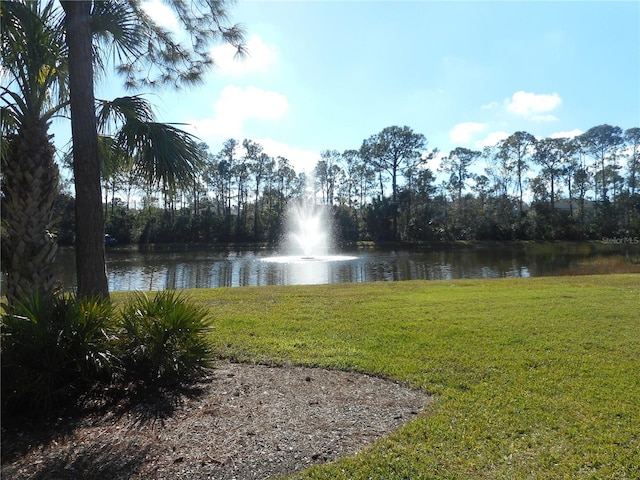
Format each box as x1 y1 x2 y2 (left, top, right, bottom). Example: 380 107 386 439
2 294 119 414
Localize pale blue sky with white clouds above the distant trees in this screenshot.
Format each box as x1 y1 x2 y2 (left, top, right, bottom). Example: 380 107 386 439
55 0 640 171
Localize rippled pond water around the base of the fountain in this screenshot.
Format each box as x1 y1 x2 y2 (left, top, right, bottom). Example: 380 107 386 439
52 242 640 291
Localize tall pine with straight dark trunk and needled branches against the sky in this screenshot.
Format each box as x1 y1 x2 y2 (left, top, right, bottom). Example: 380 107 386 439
60 0 243 297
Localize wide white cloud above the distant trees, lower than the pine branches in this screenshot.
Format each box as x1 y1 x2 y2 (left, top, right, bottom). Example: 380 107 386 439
189 86 289 139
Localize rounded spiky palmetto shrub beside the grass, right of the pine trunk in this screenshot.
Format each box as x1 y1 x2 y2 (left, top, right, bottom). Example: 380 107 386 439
122 290 212 383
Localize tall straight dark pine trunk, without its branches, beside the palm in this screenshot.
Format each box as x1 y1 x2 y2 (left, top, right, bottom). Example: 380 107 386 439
60 1 109 298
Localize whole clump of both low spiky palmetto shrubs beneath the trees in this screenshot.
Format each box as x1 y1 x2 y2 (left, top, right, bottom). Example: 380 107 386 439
1 291 212 416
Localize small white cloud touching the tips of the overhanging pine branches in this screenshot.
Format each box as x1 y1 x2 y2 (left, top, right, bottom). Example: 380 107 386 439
211 35 278 75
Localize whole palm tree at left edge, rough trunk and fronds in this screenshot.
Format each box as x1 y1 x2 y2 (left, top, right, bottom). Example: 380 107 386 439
0 1 68 305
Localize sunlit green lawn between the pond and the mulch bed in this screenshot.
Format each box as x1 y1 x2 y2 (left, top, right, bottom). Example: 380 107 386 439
118 275 640 479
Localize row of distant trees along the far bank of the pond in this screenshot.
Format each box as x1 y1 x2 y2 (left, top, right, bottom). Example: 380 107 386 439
51 125 640 246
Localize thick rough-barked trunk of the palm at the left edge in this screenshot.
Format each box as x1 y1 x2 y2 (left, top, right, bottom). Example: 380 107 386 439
2 120 59 306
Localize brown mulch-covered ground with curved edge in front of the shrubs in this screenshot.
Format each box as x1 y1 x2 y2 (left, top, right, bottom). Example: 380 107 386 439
1 363 431 480
